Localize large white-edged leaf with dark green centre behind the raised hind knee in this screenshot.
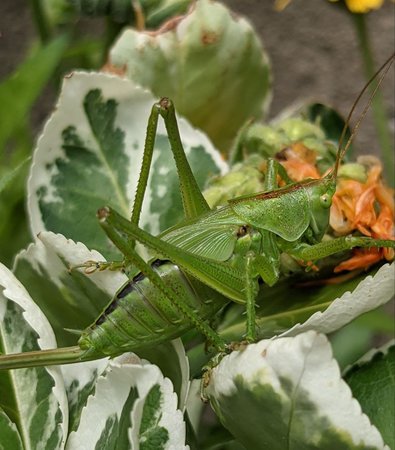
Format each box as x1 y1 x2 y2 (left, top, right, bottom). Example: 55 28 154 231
28 73 227 259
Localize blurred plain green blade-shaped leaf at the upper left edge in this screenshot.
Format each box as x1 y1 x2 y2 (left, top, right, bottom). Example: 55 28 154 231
0 35 69 149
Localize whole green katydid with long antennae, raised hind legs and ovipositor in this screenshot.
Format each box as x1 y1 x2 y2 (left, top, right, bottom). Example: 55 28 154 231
0 56 395 369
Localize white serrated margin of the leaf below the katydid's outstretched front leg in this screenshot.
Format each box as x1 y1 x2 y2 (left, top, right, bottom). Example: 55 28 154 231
279 263 395 337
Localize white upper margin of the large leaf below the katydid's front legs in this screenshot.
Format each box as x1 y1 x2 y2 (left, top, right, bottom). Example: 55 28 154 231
206 331 390 450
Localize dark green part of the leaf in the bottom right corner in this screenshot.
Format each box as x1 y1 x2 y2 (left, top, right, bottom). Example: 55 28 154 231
345 341 395 449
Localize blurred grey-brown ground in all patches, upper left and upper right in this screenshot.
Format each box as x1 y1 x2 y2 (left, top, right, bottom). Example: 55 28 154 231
0 0 395 153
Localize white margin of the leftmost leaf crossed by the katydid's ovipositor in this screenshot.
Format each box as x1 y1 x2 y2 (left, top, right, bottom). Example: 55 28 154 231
0 263 69 448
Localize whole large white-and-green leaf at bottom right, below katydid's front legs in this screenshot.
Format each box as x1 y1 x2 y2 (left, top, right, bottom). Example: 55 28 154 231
206 331 388 450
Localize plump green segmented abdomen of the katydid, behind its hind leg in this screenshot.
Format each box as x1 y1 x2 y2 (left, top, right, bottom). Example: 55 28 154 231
78 259 229 355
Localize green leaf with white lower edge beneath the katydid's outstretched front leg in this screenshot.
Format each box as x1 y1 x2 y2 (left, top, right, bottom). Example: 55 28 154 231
220 264 394 340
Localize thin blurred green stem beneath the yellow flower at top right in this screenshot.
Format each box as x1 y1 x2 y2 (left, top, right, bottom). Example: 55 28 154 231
352 14 395 186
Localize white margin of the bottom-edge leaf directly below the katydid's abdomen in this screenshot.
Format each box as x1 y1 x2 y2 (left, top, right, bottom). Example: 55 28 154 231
66 353 189 450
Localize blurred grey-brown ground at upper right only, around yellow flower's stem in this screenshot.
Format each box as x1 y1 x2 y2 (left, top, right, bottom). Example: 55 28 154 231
227 0 395 153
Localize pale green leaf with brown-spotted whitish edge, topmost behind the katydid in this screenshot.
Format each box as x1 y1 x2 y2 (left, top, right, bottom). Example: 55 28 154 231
109 0 270 153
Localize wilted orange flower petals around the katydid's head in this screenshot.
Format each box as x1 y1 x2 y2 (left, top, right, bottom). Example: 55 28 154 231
277 148 395 272
